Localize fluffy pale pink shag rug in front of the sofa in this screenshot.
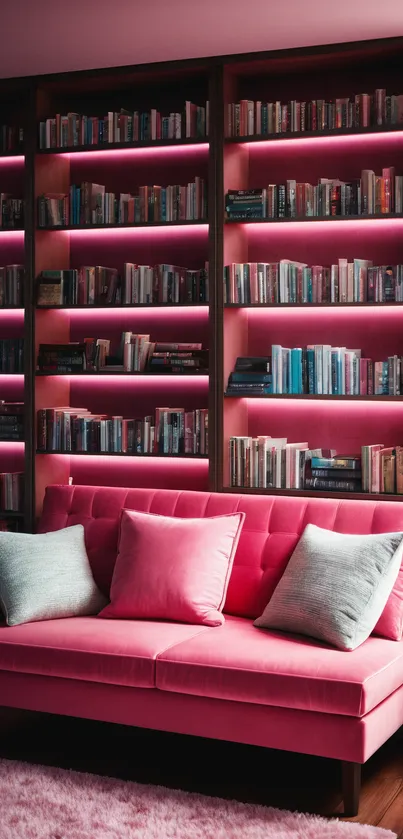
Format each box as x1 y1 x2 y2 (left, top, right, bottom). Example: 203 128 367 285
0 760 395 839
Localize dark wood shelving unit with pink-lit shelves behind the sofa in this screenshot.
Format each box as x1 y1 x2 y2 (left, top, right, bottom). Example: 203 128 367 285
0 37 403 530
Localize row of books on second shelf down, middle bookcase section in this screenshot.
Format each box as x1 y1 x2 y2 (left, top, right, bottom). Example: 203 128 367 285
38 177 207 227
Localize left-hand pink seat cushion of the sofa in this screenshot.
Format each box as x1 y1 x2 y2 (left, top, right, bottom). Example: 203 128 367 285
0 617 213 688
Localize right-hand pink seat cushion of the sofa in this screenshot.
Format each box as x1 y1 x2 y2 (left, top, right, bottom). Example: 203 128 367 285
156 615 403 717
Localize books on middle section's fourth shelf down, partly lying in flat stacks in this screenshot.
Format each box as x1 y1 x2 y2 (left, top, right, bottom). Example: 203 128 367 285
38 340 208 374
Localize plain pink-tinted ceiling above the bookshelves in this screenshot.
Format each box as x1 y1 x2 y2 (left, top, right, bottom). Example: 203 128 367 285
0 0 403 77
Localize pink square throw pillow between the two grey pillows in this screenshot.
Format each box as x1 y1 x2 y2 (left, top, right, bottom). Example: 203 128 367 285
99 510 245 626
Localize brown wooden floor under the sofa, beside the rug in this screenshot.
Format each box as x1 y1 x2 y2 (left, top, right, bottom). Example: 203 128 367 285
0 712 403 839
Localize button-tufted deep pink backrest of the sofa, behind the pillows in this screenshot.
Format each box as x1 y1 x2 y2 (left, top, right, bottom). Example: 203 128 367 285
38 486 403 618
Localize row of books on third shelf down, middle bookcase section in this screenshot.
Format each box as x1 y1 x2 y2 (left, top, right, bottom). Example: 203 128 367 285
37 262 209 306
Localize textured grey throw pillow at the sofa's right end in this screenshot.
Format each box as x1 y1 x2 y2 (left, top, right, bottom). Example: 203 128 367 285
255 524 403 650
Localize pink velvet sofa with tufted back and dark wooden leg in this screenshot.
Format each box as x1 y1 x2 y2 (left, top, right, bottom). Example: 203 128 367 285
0 486 403 813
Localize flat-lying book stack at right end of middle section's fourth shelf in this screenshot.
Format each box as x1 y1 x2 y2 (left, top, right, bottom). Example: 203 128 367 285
149 342 209 375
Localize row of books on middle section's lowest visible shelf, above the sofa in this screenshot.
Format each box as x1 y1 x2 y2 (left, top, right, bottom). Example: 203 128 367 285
37 407 208 455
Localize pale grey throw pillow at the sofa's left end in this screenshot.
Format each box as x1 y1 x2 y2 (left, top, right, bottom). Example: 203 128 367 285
0 524 107 626
